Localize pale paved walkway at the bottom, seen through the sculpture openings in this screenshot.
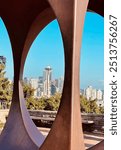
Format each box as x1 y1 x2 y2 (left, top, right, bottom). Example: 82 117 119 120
0 128 104 149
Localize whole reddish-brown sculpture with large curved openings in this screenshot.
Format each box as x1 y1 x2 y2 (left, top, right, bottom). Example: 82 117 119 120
0 0 104 150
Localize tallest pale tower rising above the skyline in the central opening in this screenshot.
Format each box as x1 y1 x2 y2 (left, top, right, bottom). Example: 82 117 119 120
43 66 52 97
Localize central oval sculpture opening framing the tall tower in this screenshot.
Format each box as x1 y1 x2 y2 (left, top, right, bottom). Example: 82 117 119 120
23 20 64 136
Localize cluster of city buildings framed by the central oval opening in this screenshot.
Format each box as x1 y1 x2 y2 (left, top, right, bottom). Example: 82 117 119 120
24 66 64 98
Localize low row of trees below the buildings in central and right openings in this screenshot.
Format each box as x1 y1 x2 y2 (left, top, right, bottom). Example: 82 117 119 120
26 93 104 114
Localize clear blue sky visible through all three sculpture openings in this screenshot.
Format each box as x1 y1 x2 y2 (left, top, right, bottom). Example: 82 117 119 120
0 13 104 89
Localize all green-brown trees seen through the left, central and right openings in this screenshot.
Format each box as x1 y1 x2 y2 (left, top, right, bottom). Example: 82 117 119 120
0 61 104 114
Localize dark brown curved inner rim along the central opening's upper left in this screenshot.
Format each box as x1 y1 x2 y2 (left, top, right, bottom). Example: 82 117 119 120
20 8 56 79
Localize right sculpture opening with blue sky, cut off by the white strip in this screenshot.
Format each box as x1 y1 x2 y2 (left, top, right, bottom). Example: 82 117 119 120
80 12 104 148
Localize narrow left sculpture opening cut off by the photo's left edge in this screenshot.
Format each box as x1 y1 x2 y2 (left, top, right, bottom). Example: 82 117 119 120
0 18 14 133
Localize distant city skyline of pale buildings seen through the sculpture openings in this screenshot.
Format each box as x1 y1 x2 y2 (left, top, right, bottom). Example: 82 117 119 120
23 66 104 99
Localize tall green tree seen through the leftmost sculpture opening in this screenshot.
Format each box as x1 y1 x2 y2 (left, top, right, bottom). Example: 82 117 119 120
0 62 12 108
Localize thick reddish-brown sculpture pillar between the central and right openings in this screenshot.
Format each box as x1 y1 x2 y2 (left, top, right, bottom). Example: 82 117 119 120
40 0 88 150
